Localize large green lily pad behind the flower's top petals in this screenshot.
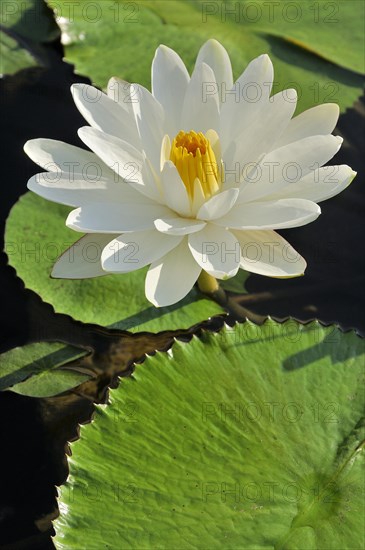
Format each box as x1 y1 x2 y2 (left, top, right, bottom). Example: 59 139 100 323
50 0 363 113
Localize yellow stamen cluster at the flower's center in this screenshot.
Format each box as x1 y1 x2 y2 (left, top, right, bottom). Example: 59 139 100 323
170 130 221 200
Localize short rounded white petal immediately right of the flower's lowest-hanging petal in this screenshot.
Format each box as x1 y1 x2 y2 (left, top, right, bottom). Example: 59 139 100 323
189 224 240 279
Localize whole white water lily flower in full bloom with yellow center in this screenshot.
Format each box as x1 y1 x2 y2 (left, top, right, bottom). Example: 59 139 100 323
25 40 355 306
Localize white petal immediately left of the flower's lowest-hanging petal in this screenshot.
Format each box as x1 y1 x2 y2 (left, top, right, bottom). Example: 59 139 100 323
101 230 182 273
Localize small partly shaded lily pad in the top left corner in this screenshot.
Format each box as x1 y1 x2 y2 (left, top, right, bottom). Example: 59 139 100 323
0 0 60 75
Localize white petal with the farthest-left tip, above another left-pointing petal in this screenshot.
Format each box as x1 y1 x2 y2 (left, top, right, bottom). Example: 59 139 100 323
24 138 118 179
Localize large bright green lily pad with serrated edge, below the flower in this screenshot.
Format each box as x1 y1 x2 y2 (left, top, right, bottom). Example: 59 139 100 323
54 320 365 550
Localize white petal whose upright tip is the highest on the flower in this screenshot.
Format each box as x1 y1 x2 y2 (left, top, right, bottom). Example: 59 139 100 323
195 38 233 95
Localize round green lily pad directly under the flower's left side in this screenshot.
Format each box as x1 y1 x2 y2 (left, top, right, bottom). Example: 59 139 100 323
6 192 224 332
